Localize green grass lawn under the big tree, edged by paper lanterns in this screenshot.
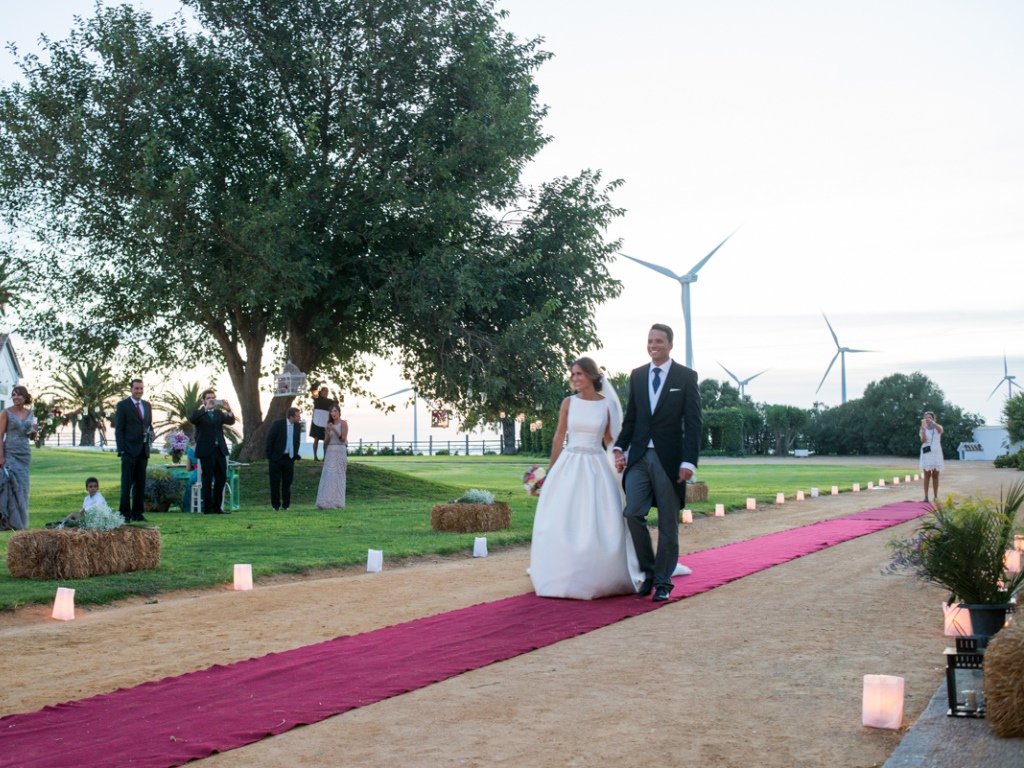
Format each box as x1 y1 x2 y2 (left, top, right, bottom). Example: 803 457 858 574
0 449 892 610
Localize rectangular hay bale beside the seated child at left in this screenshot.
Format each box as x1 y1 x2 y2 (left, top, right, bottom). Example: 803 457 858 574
7 526 160 579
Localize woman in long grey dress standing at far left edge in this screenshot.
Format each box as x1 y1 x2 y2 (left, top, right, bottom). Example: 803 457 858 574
0 386 36 530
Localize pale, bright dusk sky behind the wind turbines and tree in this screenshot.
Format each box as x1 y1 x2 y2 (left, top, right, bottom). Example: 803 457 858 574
0 0 1024 440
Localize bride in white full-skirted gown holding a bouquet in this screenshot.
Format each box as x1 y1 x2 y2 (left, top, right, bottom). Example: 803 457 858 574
529 357 642 600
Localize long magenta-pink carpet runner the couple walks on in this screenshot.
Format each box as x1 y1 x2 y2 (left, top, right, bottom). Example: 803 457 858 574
0 502 929 768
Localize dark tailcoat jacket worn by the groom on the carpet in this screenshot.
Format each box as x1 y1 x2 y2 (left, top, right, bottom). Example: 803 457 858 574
615 360 703 500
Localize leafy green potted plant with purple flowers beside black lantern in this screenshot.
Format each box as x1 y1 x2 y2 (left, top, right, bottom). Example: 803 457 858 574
888 481 1024 645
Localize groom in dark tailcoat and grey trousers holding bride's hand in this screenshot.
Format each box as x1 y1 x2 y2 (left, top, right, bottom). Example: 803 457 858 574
614 323 703 602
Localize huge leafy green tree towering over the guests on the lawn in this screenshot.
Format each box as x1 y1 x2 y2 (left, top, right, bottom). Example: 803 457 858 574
0 0 621 458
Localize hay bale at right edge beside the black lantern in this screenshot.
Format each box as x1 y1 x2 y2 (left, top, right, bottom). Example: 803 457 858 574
984 616 1024 738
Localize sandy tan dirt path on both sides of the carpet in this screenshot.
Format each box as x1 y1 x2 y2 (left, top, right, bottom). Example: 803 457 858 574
6 459 1020 768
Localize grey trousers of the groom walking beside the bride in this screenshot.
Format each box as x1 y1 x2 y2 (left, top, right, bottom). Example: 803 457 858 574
623 449 682 592
